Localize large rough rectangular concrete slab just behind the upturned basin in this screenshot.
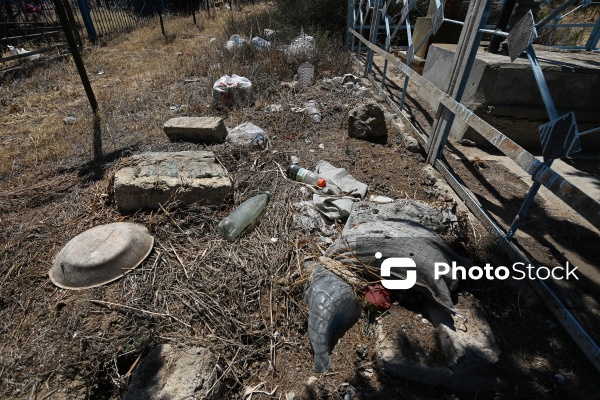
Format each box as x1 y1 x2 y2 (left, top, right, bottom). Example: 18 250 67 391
114 151 231 212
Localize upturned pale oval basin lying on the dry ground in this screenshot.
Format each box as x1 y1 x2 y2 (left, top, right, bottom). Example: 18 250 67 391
48 222 154 290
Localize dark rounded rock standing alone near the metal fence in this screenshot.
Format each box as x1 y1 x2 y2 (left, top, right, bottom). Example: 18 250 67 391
348 102 388 139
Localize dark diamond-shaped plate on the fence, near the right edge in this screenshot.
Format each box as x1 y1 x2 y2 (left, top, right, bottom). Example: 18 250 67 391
540 112 581 160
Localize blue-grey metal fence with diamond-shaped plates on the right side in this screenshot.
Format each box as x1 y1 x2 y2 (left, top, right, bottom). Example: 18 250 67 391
347 0 600 371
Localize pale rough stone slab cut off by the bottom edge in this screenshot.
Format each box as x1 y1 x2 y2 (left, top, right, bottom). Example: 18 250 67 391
125 344 223 400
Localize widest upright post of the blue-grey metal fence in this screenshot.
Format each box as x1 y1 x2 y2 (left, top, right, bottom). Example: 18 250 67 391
427 0 493 165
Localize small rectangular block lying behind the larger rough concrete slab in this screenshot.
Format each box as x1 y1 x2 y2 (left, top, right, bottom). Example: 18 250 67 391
163 117 227 143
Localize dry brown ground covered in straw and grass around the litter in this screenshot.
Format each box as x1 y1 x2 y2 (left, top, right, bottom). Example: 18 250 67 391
0 5 599 399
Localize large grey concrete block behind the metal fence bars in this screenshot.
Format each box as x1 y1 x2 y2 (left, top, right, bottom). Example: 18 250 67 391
418 44 600 151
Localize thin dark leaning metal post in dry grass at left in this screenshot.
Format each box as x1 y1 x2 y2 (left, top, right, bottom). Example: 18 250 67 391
53 0 102 161
